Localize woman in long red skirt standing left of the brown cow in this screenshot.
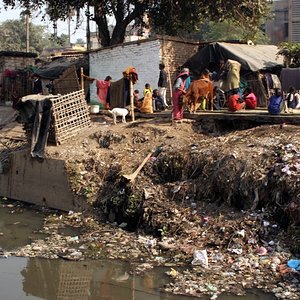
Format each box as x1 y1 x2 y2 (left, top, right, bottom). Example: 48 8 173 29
173 68 191 121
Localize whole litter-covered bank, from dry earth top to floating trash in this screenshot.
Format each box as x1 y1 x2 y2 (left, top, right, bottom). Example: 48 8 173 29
3 114 300 299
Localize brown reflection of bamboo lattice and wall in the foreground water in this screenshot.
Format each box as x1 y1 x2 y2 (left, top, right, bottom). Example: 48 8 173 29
21 258 183 300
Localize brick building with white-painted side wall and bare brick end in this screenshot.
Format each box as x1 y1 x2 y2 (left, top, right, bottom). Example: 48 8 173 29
89 36 199 100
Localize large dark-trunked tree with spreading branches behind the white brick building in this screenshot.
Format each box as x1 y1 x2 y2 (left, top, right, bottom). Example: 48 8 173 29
3 0 272 46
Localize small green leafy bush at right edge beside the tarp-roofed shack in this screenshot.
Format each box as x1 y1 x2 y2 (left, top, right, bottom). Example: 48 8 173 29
277 42 300 68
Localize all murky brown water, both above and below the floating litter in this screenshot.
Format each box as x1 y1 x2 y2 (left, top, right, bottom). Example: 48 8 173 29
0 202 275 300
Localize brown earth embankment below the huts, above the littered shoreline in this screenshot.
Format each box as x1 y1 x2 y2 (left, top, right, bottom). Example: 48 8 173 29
47 115 300 253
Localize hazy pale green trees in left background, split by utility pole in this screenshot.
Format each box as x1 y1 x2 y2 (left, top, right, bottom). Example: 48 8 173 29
0 18 68 54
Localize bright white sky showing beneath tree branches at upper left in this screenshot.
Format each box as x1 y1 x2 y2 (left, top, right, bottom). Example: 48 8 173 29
0 0 95 43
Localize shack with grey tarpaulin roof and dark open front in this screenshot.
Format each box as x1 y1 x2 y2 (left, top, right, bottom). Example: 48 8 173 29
184 42 283 107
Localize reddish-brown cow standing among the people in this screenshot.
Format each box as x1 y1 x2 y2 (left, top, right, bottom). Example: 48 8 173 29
183 78 214 113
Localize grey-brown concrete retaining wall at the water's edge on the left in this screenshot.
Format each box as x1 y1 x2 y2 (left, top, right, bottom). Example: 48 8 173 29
0 151 87 211
